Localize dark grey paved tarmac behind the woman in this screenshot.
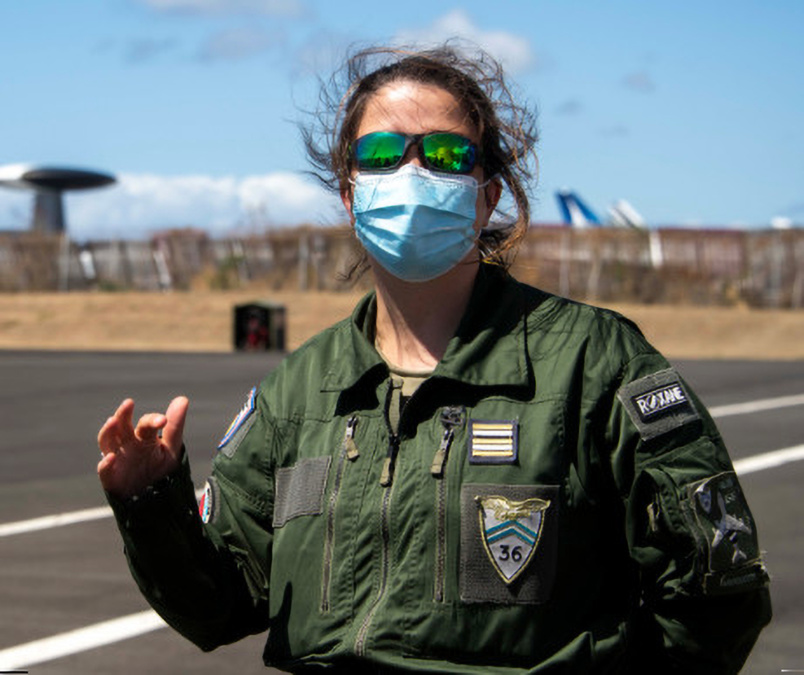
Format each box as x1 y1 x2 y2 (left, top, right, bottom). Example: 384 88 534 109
0 351 804 675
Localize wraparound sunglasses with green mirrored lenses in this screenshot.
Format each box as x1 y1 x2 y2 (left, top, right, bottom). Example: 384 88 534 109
352 131 479 173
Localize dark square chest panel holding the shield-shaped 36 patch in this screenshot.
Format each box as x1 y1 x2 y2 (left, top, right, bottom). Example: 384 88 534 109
460 483 560 605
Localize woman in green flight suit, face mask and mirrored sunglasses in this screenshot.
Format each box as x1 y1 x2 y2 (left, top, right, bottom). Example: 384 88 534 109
98 48 770 673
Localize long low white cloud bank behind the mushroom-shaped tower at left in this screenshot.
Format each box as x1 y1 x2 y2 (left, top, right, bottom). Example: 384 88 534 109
0 172 345 241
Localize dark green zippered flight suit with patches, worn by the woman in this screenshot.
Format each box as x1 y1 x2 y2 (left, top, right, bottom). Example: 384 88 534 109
105 265 771 675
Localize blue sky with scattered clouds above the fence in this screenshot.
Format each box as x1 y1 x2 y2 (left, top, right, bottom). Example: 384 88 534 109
0 0 804 239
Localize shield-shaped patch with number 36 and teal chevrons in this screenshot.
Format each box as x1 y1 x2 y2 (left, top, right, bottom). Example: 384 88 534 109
475 496 550 584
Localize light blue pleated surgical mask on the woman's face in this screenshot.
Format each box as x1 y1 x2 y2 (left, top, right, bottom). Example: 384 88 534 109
352 164 478 281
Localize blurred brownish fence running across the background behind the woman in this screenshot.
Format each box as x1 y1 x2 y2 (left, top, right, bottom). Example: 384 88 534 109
0 225 804 308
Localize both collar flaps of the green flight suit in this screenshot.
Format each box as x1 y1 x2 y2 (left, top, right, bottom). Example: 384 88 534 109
321 264 531 391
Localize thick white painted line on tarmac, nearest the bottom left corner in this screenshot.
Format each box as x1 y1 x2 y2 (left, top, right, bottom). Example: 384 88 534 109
0 610 167 670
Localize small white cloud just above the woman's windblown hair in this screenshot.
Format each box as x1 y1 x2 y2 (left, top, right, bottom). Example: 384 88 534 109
395 9 535 71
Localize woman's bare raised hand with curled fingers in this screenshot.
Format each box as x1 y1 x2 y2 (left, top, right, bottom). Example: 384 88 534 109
98 396 190 499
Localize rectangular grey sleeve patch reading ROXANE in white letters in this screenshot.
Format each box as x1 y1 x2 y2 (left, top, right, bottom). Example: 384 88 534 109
617 368 700 441
